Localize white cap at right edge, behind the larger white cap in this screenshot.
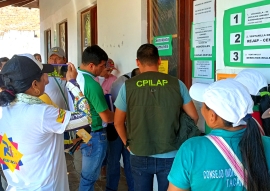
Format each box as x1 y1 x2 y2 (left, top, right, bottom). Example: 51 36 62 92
234 69 268 96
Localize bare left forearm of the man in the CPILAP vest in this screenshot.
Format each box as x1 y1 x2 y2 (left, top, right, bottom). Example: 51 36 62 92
114 108 127 145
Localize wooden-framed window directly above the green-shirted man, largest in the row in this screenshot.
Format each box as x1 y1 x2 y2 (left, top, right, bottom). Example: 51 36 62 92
81 5 97 51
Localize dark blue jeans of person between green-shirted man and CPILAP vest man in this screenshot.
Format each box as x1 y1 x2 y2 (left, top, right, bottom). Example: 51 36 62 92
106 137 134 191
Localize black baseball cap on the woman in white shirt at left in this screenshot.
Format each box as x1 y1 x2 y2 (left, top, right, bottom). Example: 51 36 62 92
1 54 54 82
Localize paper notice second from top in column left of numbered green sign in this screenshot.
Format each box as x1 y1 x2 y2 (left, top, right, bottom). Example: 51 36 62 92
193 22 214 48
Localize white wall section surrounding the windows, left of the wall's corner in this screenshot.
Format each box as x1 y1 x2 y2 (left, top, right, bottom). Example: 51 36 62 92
39 0 96 66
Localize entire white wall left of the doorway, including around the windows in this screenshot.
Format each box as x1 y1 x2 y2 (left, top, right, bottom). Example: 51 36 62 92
40 0 147 75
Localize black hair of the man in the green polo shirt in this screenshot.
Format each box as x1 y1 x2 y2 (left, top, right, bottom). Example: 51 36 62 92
82 45 108 66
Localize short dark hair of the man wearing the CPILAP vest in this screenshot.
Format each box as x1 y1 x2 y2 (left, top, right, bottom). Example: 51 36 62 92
137 44 159 65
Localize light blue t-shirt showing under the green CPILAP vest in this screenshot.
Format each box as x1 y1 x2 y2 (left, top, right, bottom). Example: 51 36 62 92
114 80 191 158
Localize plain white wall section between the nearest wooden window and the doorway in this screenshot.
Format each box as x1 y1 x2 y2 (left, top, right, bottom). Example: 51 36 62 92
97 0 147 74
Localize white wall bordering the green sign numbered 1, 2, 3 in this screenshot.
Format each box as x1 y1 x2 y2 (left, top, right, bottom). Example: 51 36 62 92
216 0 270 83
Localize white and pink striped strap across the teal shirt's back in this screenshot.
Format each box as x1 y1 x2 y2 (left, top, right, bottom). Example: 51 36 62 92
206 135 247 189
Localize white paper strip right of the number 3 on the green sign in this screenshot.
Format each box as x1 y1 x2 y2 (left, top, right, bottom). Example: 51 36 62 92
243 49 270 64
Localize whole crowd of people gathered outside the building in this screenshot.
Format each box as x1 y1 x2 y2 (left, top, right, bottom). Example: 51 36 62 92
0 44 270 191
